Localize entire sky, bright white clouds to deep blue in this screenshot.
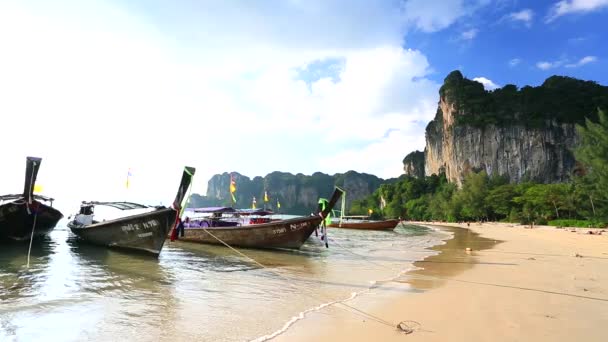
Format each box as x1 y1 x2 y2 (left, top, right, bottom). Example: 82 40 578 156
0 0 608 210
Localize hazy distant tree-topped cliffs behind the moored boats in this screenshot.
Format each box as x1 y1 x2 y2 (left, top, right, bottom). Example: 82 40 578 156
189 171 385 214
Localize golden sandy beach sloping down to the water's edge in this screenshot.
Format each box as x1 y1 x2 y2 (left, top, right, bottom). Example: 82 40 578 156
275 223 608 341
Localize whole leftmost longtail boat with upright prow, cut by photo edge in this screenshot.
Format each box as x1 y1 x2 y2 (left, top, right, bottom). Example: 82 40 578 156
0 157 63 241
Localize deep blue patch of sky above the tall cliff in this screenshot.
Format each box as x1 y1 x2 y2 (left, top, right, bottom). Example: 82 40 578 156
404 0 608 86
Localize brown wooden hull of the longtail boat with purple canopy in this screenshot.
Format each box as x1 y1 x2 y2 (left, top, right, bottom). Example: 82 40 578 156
179 216 321 249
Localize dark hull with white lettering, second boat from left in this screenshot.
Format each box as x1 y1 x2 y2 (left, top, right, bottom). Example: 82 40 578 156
68 208 177 256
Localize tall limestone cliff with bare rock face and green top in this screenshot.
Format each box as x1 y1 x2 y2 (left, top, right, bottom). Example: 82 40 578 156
424 71 608 184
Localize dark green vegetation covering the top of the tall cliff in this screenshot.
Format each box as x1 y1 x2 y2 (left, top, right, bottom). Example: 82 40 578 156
427 71 608 132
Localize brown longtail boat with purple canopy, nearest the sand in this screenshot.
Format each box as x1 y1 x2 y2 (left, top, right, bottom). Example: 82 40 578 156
179 189 342 249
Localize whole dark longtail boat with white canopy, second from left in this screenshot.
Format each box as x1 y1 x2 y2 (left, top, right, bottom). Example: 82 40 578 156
68 167 195 256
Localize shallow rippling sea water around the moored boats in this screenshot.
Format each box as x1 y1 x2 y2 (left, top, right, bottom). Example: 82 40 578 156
0 220 446 341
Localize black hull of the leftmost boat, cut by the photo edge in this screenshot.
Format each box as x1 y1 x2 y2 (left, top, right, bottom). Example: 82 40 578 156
0 200 63 241
